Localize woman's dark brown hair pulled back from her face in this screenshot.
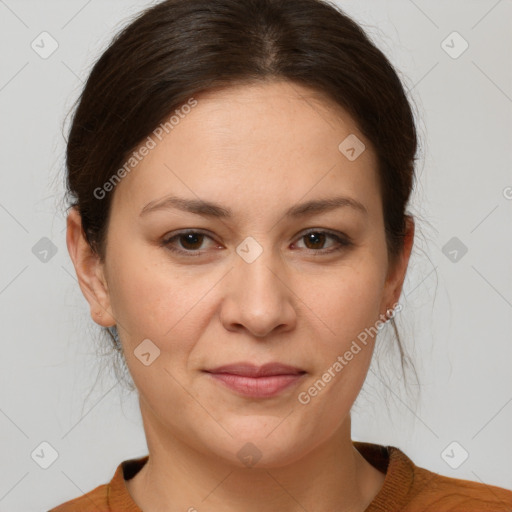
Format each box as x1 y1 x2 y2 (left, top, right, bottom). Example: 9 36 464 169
66 0 417 400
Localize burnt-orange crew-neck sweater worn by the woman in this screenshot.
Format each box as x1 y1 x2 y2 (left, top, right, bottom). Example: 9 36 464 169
49 441 512 512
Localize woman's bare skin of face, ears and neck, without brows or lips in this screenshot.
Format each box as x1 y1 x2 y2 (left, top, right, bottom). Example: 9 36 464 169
67 82 414 512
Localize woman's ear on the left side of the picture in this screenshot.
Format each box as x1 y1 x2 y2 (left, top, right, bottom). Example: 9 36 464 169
66 208 116 327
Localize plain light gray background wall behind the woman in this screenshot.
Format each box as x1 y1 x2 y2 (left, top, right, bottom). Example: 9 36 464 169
0 0 512 512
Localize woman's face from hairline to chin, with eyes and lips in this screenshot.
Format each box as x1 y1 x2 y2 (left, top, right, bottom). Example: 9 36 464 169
68 82 409 467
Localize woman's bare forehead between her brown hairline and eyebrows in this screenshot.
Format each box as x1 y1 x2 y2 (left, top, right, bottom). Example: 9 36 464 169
108 82 378 221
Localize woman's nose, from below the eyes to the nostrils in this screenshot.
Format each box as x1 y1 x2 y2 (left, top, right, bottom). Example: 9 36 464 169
220 246 298 338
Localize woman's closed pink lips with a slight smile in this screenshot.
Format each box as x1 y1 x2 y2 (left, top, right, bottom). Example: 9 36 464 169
200 363 307 398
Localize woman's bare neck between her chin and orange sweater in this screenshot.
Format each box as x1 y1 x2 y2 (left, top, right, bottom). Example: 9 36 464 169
127 400 385 512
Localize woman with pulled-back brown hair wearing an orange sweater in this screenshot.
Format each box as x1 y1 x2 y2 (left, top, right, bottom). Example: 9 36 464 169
53 0 512 512
